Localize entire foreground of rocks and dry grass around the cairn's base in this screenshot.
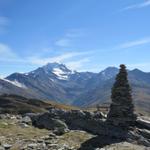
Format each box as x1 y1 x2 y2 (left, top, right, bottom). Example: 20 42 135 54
0 108 150 150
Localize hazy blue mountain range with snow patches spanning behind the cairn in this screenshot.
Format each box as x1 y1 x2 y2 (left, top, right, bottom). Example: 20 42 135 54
0 63 150 111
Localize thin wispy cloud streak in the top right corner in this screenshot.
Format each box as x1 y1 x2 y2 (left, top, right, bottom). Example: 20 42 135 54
121 0 150 11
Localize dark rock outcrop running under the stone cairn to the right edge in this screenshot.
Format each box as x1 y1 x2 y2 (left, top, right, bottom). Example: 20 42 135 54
30 109 150 147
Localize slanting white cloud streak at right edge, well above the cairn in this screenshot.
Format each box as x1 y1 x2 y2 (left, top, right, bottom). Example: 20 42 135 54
117 37 150 49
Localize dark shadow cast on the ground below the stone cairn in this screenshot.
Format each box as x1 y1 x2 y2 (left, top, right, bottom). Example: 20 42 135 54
78 121 129 150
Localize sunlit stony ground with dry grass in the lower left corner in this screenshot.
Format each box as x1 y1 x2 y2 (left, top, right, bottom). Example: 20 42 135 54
0 115 94 150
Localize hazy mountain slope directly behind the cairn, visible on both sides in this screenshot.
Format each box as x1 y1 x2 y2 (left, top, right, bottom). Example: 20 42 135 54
75 69 150 114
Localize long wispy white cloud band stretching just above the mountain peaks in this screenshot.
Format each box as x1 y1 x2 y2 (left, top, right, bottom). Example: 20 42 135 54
0 37 150 71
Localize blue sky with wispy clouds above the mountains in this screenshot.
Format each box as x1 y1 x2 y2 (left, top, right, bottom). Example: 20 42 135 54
0 0 150 76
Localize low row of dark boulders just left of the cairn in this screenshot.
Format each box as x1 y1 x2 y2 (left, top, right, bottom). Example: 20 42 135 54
31 109 105 134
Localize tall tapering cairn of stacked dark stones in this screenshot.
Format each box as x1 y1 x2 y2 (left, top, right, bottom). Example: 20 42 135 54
107 65 136 127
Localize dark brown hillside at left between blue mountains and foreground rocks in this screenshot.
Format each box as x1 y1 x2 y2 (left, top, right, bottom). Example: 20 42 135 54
0 94 77 114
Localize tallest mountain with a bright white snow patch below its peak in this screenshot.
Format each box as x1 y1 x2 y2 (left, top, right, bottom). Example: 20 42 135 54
6 63 94 102
